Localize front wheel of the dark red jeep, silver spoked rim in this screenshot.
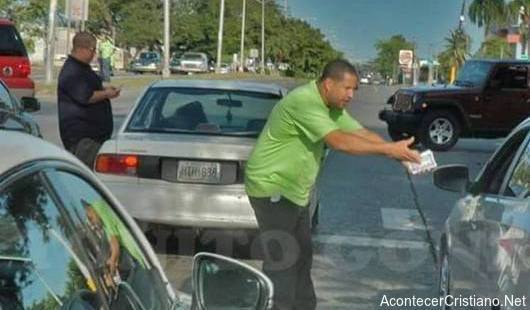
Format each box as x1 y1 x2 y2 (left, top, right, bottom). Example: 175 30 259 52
418 111 460 151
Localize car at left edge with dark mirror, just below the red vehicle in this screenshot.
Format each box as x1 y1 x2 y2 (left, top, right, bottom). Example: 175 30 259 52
0 80 42 137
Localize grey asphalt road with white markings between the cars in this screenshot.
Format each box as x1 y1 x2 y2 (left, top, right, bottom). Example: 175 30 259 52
31 85 500 309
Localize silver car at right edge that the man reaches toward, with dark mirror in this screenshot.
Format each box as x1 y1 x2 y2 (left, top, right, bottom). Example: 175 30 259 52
433 119 530 309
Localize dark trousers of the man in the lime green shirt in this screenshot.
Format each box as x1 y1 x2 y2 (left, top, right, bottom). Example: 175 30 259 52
250 197 316 310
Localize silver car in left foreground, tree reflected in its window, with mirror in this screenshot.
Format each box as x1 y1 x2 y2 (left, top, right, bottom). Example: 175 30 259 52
0 133 273 310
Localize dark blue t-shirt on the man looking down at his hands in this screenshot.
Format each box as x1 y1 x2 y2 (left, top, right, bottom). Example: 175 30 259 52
57 56 113 147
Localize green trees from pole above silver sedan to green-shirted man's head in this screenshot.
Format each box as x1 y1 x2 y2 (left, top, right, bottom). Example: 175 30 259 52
172 0 342 77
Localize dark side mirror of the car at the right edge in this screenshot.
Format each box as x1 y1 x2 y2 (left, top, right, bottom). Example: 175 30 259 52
433 165 469 193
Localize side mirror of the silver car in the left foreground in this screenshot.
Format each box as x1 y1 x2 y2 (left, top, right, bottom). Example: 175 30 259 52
193 253 273 310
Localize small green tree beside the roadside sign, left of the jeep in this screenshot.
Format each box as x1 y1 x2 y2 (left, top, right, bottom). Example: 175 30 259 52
375 35 414 76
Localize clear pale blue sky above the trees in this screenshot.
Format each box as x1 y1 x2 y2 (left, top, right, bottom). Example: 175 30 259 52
277 0 484 62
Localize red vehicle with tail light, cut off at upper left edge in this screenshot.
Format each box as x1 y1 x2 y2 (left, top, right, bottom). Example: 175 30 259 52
0 18 35 98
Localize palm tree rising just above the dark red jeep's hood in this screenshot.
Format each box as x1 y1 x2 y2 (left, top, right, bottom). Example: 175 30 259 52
442 28 471 82
